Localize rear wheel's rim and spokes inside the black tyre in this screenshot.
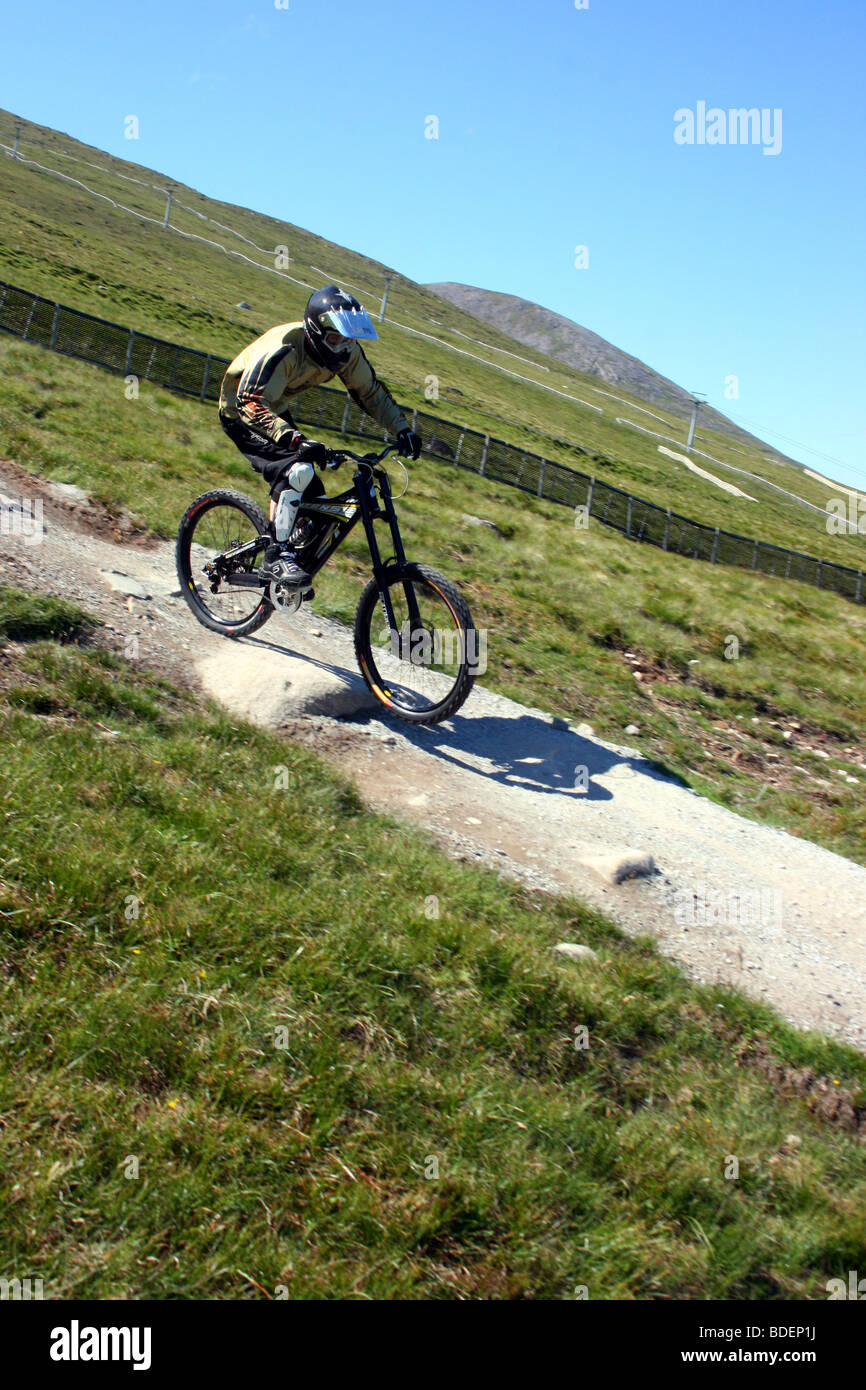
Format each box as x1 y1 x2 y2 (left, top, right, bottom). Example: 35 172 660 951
186 502 264 627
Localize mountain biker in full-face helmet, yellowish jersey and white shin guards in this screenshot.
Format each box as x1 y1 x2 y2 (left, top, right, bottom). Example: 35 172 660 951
220 285 421 589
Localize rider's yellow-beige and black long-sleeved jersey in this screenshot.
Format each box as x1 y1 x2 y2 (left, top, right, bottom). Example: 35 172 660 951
220 322 409 442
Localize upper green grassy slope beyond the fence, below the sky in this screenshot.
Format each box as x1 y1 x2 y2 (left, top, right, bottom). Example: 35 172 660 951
0 102 866 569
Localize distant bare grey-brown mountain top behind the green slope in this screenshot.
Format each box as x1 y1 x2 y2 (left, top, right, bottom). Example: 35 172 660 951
427 281 778 453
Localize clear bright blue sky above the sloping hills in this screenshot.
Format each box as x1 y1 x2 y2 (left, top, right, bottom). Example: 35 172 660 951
0 0 866 484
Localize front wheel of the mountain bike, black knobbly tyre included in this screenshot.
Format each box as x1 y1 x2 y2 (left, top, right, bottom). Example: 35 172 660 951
354 564 481 724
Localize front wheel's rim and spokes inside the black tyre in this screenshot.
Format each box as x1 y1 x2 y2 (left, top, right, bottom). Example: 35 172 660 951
367 580 474 714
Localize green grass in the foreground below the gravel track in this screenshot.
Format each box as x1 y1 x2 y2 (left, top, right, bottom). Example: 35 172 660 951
0 591 866 1300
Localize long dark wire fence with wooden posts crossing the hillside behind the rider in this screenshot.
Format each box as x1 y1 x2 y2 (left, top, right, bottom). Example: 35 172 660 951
0 281 866 603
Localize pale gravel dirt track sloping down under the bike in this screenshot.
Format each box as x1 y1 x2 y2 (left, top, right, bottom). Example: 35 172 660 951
0 463 866 1051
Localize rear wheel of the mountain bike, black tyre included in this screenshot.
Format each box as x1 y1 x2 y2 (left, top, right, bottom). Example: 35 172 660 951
175 488 274 637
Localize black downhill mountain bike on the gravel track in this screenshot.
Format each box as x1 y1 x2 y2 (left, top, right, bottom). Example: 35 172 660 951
177 445 478 724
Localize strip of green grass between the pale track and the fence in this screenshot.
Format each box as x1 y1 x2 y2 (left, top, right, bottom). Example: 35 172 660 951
6 339 866 862
